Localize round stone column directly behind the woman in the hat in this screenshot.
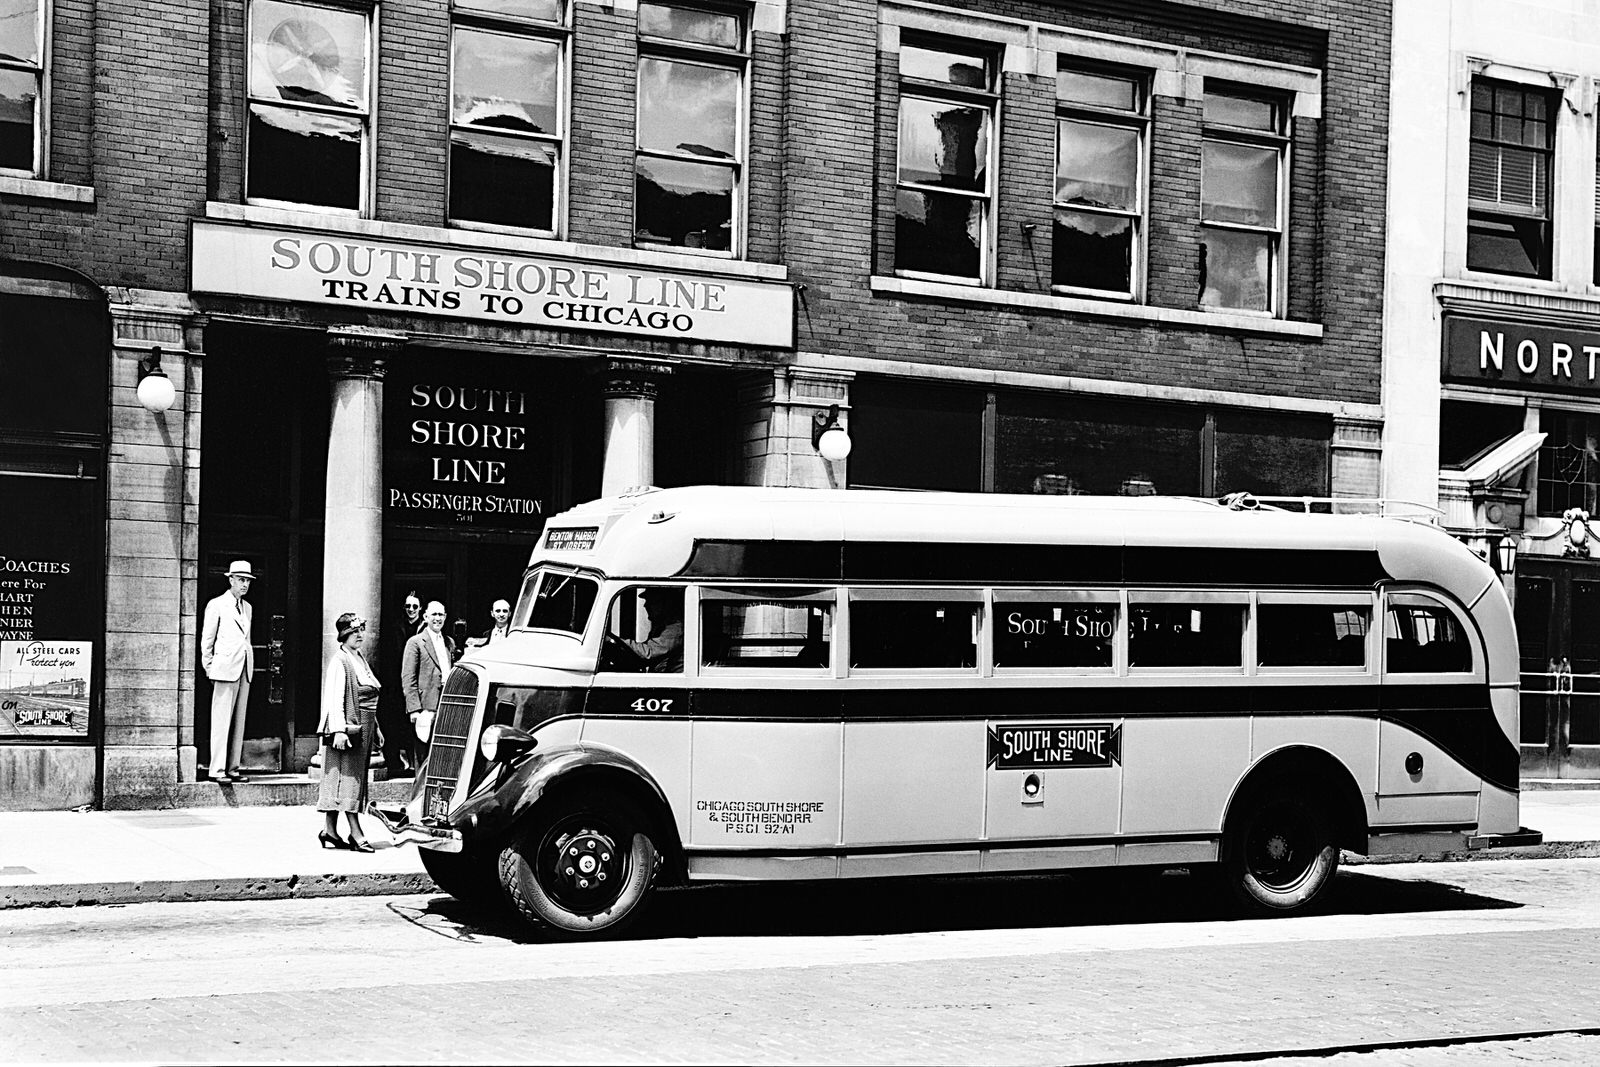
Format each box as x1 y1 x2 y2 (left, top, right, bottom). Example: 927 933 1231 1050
322 326 406 665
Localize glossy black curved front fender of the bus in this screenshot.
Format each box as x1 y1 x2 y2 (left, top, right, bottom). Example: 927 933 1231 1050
451 744 683 876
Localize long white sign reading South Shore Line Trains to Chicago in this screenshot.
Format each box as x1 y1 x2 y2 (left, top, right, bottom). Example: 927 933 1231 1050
190 222 794 349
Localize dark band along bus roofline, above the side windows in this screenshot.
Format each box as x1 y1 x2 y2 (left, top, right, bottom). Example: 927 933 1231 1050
678 539 1390 589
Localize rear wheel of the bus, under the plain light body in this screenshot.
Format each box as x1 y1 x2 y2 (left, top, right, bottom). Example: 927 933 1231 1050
1222 787 1339 915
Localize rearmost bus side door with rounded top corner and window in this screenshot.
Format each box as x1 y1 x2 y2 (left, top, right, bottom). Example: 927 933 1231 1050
1373 590 1496 830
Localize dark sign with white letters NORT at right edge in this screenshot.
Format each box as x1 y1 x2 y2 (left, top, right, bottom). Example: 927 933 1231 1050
1443 317 1600 395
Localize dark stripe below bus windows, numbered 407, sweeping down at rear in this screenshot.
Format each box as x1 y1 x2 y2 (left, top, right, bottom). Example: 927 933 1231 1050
584 683 1520 792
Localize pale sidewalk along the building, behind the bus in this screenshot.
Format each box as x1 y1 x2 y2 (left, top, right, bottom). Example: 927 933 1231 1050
0 782 1600 909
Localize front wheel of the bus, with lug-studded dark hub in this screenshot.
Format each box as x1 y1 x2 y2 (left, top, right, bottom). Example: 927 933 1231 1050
499 793 661 937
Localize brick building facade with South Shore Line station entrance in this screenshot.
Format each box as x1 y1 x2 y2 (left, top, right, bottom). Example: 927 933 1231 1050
0 0 1389 806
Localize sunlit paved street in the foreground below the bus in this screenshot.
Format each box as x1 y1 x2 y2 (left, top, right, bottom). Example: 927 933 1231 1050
0 859 1600 1067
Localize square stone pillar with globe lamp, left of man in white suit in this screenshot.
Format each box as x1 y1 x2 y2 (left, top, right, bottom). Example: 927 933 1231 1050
101 288 205 808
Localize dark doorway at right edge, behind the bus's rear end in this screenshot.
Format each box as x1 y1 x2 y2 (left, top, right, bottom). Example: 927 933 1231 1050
1517 557 1600 779
